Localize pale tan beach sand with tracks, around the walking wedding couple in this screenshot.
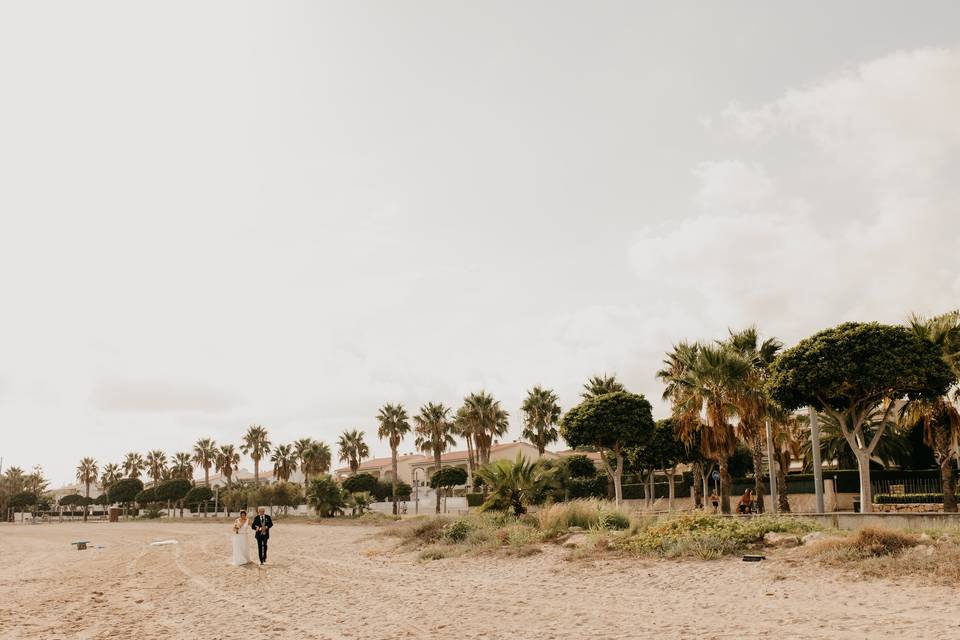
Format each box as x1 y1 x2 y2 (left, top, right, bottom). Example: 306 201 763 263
0 521 960 640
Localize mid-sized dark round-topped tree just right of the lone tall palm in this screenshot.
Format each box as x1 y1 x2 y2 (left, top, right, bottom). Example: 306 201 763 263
560 391 655 505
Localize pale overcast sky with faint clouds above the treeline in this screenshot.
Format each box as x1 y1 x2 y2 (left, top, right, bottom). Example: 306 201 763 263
0 0 960 484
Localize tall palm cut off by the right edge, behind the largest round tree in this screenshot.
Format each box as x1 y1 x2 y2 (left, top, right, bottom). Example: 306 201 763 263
900 311 960 513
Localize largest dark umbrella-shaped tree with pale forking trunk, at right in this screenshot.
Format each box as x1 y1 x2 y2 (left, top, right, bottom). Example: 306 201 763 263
767 322 954 511
